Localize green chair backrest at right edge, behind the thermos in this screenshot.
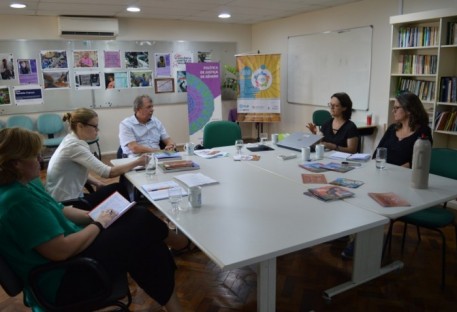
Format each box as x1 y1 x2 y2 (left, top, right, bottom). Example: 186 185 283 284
430 148 457 180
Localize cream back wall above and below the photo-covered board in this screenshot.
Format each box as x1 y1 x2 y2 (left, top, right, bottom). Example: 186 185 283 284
0 15 251 154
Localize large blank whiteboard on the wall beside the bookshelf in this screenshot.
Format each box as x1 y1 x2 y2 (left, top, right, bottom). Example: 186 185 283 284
287 26 373 110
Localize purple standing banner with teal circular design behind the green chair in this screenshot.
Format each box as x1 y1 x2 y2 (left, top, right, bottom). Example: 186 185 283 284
186 62 222 144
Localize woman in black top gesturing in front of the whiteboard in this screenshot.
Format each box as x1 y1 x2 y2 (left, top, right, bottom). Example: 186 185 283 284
307 92 359 154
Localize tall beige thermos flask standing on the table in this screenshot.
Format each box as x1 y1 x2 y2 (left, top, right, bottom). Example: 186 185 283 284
411 135 432 189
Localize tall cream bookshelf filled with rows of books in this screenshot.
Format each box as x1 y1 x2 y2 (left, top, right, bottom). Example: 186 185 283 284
389 10 457 147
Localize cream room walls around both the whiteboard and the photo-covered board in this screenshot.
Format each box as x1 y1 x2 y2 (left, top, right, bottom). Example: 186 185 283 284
0 0 457 153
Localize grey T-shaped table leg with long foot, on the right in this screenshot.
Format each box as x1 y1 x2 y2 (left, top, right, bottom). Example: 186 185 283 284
323 226 403 300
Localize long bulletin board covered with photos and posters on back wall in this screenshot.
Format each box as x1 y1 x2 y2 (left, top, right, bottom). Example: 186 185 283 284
0 40 236 115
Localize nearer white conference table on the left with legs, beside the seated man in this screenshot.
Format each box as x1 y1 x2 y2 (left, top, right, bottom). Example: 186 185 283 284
112 153 388 311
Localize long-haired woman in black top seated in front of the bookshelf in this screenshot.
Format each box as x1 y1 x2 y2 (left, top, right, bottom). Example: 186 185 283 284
373 92 433 168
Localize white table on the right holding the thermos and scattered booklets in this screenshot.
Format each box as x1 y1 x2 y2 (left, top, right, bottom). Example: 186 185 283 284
245 146 457 219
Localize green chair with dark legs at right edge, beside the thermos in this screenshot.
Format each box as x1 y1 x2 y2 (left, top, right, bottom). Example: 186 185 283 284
386 148 457 289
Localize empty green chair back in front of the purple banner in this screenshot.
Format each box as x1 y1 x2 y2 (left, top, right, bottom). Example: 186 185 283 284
203 120 241 148
